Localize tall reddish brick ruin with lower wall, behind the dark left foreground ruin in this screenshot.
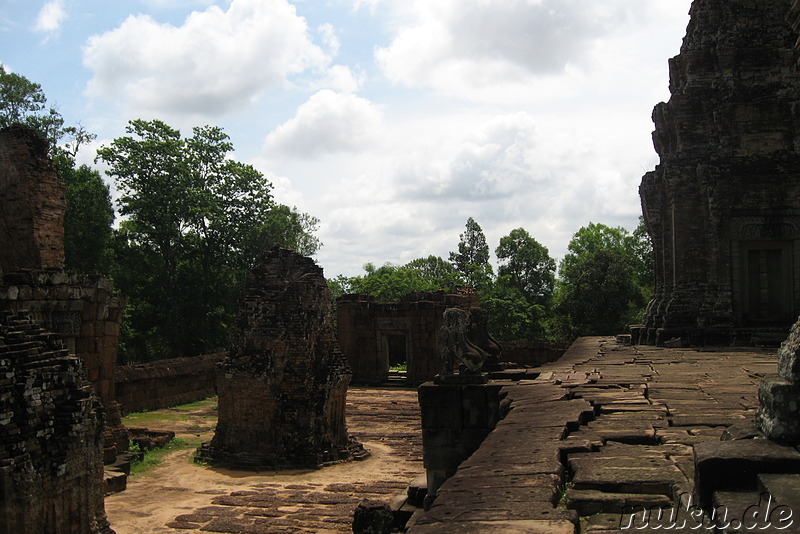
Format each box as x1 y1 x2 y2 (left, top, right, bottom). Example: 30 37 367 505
0 126 128 462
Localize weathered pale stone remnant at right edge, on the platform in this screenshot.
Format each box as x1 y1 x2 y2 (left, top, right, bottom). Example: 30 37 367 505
756 319 800 445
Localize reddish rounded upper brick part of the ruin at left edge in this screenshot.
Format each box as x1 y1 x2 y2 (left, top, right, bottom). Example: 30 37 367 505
0 125 66 274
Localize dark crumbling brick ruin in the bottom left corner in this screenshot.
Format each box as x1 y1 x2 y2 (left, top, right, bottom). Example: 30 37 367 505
0 311 113 534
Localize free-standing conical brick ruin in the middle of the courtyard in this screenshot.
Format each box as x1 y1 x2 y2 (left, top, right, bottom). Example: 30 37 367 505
199 248 359 470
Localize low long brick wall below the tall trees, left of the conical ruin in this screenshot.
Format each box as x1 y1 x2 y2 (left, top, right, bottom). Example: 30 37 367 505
116 353 227 414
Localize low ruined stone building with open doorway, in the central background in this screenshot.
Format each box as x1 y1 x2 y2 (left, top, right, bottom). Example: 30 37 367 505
337 290 478 384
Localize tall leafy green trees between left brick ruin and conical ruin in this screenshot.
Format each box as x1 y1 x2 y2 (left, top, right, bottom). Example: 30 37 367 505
98 120 319 361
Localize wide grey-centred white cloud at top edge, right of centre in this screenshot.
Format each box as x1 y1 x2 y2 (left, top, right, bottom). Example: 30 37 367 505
376 0 660 94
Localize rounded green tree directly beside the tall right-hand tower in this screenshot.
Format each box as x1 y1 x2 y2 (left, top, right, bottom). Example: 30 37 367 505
554 223 645 340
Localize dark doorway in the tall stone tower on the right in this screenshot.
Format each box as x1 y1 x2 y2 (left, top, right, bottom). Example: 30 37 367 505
741 241 793 325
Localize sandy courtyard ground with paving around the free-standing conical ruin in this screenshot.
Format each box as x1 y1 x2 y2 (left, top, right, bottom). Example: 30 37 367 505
105 388 424 534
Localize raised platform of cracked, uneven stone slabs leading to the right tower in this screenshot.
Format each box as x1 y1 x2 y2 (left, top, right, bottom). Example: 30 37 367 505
408 338 788 534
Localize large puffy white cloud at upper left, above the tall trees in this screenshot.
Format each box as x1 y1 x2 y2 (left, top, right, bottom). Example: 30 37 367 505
83 0 330 116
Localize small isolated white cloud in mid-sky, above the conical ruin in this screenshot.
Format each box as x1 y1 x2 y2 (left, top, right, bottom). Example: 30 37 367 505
266 89 381 158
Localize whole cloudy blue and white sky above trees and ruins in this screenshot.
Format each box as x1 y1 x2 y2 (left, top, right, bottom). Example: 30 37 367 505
0 0 691 277
